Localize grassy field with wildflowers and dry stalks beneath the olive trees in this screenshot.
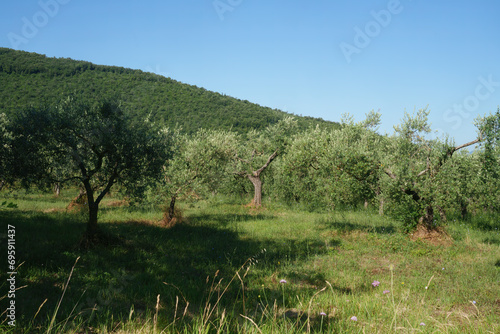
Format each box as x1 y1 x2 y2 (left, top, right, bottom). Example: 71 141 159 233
0 191 500 333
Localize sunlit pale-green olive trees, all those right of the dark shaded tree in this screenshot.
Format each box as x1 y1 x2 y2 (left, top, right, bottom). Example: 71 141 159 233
161 105 500 234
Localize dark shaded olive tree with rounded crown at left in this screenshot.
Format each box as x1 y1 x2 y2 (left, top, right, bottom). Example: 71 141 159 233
13 98 170 242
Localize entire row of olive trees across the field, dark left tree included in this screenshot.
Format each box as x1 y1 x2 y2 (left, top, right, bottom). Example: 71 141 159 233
0 98 500 236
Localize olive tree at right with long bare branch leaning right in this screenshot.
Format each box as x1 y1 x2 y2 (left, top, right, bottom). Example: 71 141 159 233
383 109 498 230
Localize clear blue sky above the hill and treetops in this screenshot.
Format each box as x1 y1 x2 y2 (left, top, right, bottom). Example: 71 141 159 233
0 0 500 144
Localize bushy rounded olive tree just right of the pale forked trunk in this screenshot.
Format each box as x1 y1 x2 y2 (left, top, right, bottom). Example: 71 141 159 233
281 111 381 208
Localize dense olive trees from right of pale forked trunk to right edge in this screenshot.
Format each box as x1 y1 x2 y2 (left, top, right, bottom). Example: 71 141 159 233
279 109 500 229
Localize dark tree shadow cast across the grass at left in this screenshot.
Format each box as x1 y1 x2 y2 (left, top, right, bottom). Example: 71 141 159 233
0 210 332 333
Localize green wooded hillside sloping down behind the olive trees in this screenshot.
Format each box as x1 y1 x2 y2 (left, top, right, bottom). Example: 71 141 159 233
0 48 338 133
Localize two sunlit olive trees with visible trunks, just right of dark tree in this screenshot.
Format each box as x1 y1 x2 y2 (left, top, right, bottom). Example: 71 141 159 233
156 118 296 224
